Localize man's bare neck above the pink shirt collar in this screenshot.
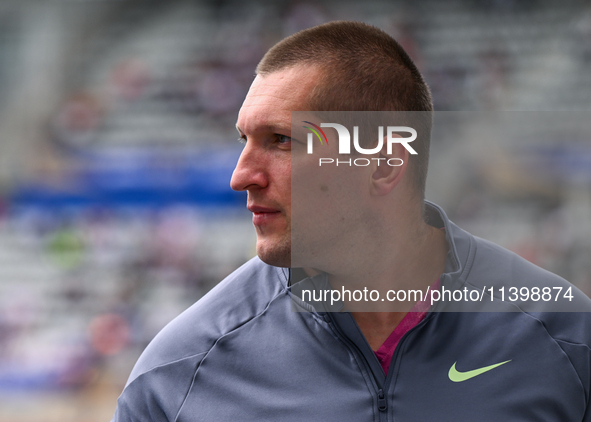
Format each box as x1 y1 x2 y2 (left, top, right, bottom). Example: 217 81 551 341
306 199 448 350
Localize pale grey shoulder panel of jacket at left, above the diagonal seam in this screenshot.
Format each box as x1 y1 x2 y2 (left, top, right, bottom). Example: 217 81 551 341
128 257 288 384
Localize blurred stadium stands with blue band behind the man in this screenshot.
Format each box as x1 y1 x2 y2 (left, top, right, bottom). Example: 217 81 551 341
0 0 591 422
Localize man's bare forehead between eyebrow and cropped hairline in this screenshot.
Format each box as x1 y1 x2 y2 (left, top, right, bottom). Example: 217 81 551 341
236 66 320 134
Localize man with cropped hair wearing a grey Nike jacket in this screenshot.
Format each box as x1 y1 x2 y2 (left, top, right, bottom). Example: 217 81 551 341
114 22 591 421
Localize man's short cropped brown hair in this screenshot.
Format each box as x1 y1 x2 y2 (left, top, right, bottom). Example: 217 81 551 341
256 21 433 199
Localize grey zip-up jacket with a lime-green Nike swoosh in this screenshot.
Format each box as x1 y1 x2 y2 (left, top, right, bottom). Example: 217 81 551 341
113 203 591 422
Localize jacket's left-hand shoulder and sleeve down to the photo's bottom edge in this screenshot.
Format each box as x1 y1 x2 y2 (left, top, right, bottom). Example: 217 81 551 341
113 258 289 422
